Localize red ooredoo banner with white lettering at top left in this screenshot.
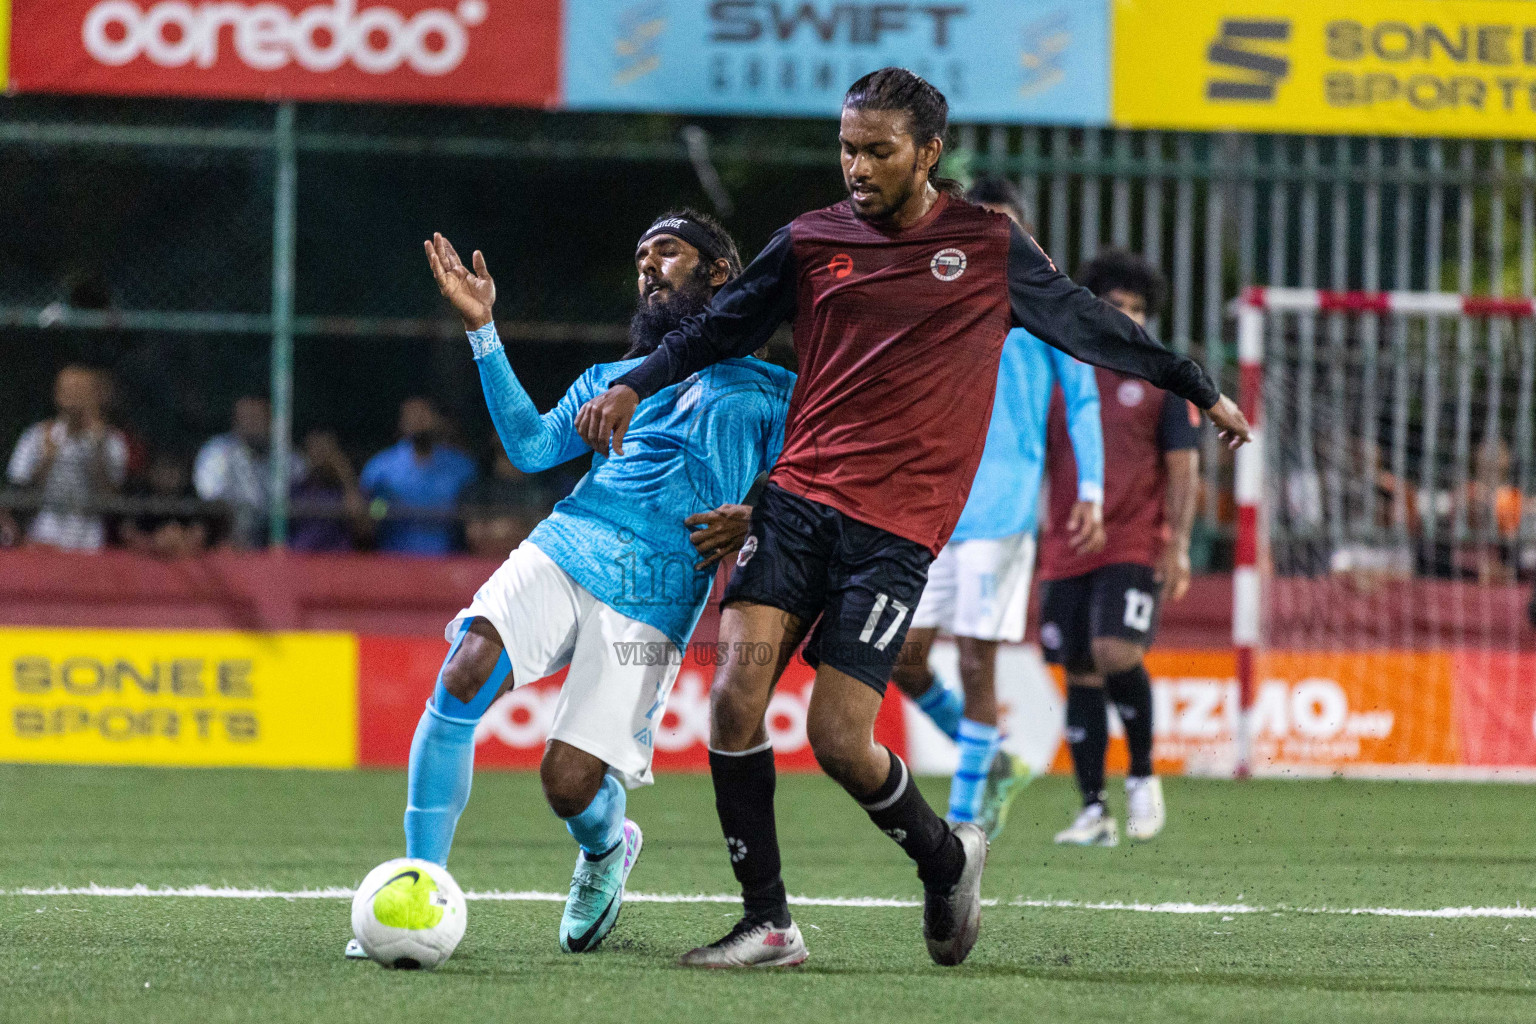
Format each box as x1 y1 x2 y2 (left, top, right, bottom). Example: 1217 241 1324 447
11 0 561 106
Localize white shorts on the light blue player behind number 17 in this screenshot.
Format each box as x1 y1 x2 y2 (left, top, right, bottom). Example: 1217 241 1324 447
912 533 1035 643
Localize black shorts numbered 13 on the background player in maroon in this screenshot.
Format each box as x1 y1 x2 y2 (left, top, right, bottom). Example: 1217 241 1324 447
1040 562 1163 672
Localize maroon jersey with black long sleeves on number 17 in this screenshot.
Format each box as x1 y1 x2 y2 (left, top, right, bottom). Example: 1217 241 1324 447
614 195 1220 553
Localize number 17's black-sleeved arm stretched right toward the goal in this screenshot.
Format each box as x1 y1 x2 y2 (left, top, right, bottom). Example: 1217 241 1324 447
1008 227 1252 448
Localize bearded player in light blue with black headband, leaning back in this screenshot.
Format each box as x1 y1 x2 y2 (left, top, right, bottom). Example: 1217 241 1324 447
347 210 794 955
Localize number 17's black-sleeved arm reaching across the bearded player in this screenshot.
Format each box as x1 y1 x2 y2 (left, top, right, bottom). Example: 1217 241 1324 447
576 227 794 454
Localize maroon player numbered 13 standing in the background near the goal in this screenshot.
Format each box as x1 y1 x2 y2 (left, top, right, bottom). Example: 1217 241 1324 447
1040 250 1200 846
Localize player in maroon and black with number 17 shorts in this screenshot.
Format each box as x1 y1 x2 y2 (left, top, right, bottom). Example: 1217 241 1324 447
578 68 1247 967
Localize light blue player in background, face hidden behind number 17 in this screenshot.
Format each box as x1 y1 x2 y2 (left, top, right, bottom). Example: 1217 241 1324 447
892 178 1104 840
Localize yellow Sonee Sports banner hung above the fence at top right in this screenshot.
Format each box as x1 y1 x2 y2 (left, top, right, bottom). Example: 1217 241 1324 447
1111 0 1536 138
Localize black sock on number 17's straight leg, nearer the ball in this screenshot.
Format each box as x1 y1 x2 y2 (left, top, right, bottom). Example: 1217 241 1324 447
710 745 790 927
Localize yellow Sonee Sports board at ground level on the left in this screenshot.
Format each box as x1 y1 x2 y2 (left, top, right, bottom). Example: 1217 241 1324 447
0 629 358 768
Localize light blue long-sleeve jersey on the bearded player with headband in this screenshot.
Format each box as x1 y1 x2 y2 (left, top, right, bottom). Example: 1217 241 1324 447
470 324 794 648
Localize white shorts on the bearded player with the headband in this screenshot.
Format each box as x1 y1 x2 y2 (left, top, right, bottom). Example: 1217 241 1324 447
445 540 682 789
